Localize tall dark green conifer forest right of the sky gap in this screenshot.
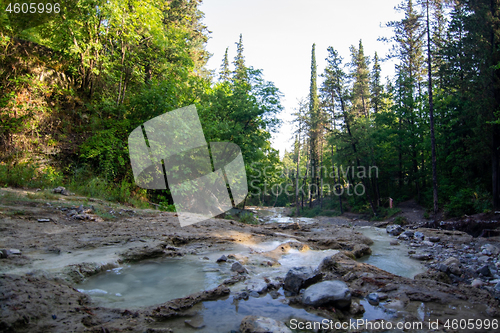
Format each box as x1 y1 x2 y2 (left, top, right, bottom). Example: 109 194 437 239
263 0 500 216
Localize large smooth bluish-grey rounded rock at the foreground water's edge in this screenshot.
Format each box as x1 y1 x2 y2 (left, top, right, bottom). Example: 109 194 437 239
302 280 351 308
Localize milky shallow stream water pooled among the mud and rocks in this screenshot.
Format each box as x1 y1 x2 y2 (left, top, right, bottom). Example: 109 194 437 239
73 208 425 332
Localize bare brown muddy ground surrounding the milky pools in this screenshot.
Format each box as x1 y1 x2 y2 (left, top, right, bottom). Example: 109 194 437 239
0 189 500 332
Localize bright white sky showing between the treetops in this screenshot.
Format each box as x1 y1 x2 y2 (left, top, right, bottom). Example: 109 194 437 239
200 0 402 156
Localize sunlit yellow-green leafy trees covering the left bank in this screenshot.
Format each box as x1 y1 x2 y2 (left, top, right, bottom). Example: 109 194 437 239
0 0 282 208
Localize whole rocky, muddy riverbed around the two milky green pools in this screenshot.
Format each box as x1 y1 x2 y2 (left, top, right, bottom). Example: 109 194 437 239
0 189 500 332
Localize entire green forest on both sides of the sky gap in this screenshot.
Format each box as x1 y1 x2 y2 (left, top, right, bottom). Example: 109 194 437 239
0 0 500 216
